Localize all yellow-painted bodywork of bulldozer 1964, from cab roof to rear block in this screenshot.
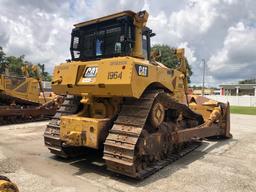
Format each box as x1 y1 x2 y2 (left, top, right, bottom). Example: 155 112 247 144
52 11 229 149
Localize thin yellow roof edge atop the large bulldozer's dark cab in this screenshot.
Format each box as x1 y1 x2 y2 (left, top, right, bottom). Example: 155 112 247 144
74 10 136 27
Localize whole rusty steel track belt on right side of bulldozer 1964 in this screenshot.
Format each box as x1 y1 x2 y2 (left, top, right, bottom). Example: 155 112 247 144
103 90 201 179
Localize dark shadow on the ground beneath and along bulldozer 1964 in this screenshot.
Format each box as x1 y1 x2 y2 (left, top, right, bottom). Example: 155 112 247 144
52 139 237 187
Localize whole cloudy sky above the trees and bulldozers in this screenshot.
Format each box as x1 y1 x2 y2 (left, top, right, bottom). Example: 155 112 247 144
0 0 256 86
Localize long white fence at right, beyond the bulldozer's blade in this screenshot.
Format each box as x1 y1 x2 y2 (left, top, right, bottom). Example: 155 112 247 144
206 95 256 107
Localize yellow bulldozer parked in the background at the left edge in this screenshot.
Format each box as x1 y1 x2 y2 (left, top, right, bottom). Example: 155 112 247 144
0 66 60 125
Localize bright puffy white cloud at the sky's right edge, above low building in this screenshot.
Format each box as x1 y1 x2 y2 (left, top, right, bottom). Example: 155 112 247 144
208 22 256 81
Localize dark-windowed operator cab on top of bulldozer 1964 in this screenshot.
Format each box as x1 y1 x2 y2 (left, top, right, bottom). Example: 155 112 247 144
70 11 154 61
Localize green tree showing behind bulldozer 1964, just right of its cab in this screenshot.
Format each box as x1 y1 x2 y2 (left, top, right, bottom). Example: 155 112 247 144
152 44 193 82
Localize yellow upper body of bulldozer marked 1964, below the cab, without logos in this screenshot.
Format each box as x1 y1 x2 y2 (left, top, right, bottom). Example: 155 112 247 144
52 57 184 100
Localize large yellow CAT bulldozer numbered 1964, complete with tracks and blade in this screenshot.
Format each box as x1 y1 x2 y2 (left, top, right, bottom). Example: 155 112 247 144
44 11 231 178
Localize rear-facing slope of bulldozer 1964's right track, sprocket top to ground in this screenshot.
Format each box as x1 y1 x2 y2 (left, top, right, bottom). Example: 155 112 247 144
103 91 158 177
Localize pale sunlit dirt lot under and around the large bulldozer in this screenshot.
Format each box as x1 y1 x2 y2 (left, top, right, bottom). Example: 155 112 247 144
0 115 256 192
